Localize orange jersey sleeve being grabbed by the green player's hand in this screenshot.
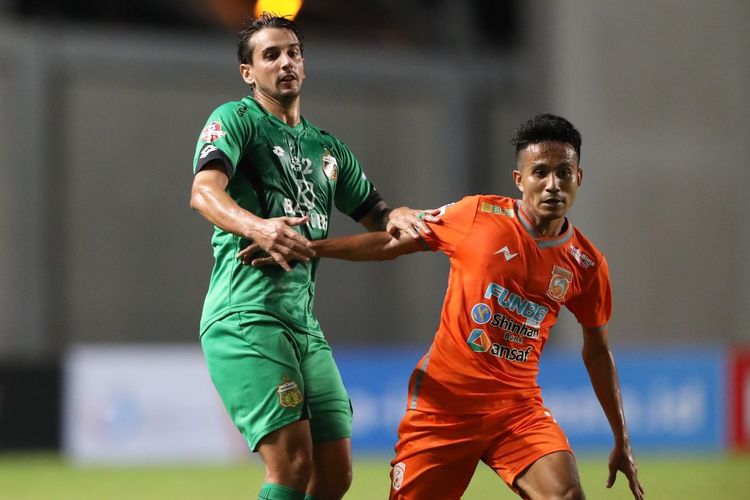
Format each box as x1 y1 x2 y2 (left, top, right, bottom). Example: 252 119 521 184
422 196 479 256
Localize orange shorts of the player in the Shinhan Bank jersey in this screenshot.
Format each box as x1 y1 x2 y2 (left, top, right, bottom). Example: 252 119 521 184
390 400 572 500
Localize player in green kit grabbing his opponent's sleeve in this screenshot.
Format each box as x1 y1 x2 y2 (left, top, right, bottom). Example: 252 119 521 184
190 14 436 500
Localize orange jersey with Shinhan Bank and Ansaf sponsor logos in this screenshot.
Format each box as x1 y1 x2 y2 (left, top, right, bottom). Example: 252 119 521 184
407 195 612 414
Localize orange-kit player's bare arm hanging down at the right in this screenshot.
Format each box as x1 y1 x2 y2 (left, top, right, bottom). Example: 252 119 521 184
582 326 644 500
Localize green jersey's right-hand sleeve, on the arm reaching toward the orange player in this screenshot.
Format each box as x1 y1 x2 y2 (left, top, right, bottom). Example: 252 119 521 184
328 136 380 220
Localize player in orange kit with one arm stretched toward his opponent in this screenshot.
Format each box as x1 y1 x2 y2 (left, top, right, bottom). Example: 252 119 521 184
241 114 644 500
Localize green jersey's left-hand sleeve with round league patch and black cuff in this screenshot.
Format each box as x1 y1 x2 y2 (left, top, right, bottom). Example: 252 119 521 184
193 101 252 179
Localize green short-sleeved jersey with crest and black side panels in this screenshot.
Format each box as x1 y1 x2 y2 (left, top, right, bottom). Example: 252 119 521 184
193 97 380 335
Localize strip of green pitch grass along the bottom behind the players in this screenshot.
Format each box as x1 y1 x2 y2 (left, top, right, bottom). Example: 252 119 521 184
0 454 750 500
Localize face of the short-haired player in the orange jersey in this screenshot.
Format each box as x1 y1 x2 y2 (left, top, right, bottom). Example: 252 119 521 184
513 142 583 221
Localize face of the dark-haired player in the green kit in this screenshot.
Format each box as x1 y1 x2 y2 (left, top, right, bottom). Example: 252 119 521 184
240 28 305 102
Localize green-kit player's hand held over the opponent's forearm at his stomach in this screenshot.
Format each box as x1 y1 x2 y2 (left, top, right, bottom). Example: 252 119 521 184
242 216 315 272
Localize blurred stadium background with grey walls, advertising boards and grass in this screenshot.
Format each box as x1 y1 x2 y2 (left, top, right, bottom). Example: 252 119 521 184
0 0 750 499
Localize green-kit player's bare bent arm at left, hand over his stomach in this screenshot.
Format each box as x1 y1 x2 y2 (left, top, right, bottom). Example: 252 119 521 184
190 161 315 271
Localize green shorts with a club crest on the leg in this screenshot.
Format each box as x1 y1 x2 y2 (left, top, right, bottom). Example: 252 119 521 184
201 312 352 451
